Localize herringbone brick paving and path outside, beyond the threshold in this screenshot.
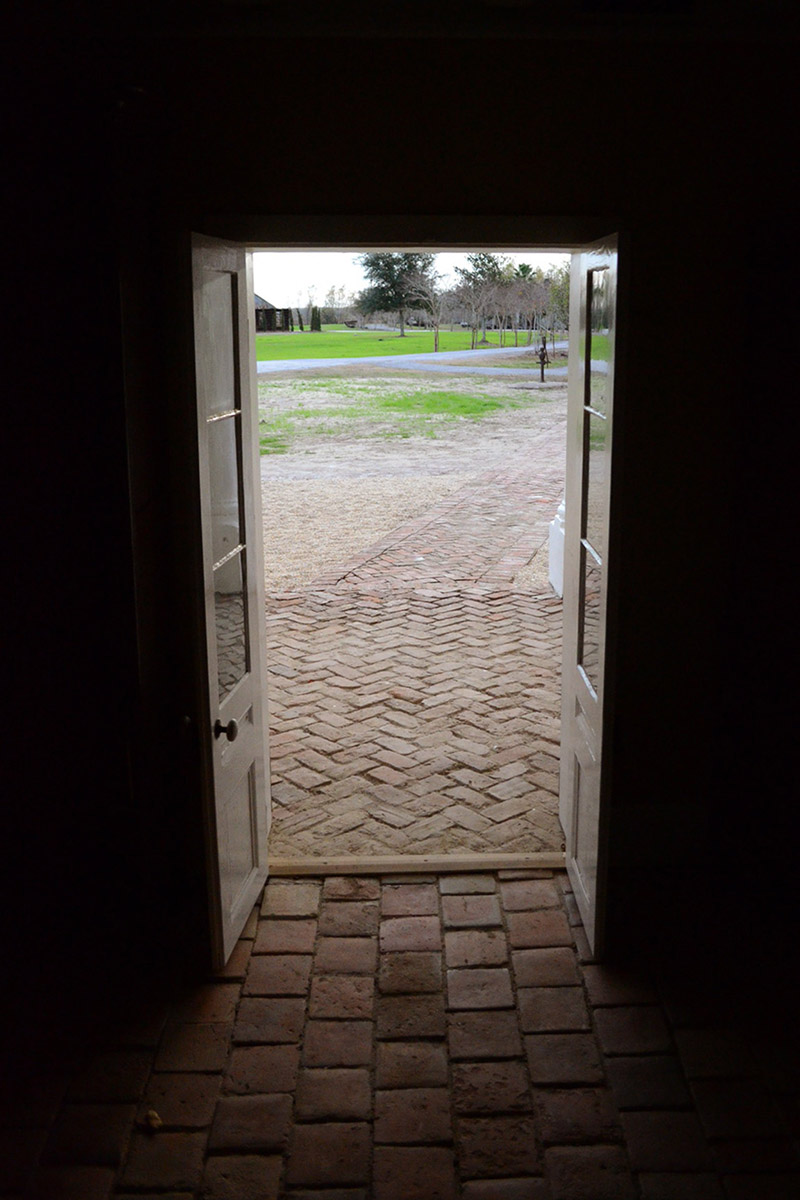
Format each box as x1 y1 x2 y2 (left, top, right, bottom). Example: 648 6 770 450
267 436 564 858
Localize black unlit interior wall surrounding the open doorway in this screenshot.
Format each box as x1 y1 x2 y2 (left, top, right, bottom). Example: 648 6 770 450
8 14 793 1012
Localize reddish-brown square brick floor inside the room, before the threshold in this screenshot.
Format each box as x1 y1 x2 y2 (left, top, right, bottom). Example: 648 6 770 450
14 871 800 1200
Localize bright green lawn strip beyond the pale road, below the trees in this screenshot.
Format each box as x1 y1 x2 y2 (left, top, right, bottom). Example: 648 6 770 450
255 325 551 362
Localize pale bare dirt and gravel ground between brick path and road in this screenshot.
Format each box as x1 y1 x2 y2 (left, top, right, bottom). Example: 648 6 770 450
259 364 566 593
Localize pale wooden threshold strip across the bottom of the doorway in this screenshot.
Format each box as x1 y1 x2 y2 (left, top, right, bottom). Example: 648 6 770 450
270 851 566 878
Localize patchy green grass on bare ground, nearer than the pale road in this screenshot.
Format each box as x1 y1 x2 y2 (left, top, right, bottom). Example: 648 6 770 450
259 378 547 455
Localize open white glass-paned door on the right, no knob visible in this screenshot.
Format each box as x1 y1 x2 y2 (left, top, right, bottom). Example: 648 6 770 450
560 238 616 954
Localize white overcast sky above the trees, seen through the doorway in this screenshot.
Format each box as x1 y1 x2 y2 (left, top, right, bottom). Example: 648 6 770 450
253 250 570 308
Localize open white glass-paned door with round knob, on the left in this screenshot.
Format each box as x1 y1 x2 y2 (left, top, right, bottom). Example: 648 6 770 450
192 238 270 967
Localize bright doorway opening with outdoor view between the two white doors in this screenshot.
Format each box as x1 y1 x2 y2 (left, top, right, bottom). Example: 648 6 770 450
255 252 569 871
